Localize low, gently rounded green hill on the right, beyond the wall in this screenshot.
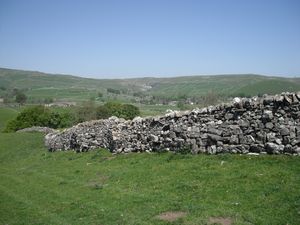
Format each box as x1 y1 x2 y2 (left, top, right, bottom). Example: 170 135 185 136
146 74 300 96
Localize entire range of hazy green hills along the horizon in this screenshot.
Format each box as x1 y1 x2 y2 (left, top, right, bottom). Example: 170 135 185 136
0 68 300 100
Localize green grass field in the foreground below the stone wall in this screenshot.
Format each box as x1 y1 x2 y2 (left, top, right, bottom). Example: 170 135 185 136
0 133 300 225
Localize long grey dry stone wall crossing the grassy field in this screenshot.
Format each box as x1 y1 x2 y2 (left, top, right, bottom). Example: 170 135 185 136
45 93 300 155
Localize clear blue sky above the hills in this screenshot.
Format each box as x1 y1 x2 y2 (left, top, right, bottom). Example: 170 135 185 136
0 0 300 78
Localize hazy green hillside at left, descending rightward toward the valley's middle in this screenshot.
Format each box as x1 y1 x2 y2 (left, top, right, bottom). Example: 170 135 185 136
0 68 137 101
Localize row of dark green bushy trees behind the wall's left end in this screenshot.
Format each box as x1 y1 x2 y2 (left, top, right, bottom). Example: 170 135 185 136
4 101 140 132
